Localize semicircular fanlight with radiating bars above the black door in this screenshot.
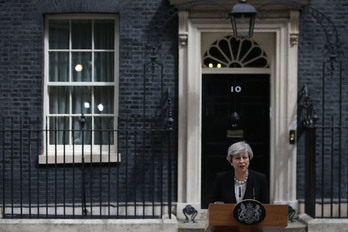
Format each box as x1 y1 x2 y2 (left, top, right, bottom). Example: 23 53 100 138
203 36 269 68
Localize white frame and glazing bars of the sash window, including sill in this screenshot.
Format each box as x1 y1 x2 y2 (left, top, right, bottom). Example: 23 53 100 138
39 14 121 164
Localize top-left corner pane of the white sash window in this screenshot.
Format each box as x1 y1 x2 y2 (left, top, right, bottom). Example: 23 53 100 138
48 20 69 49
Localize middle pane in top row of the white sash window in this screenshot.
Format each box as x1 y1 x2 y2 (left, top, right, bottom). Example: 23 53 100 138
71 20 92 49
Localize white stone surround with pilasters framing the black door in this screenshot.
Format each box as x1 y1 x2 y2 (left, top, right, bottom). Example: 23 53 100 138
177 10 299 218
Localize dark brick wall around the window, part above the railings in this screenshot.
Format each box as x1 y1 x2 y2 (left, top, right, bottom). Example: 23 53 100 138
0 0 177 117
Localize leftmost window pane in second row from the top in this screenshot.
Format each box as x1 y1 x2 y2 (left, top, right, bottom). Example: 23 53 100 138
49 52 69 82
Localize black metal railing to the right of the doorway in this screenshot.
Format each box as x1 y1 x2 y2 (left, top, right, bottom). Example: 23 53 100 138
302 82 348 218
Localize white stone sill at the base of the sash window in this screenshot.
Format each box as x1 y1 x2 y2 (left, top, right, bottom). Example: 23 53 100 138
39 152 121 164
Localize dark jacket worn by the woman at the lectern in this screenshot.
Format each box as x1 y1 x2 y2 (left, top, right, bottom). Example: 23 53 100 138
211 169 269 204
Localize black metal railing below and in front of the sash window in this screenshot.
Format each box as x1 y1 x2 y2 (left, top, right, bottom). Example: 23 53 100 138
0 117 175 219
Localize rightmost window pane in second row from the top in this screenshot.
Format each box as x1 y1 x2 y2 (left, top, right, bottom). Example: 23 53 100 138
94 52 114 82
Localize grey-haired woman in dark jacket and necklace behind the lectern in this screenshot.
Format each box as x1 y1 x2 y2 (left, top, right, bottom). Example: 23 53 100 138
212 142 269 204
